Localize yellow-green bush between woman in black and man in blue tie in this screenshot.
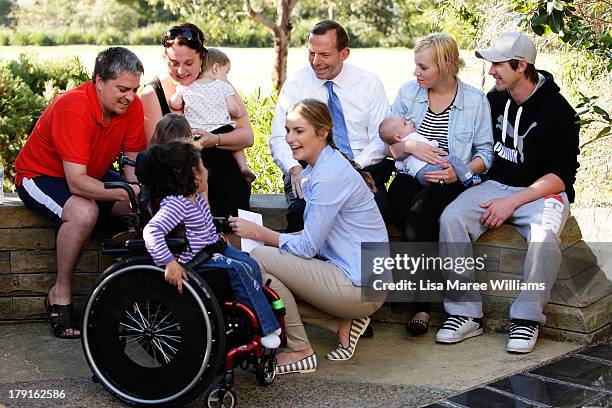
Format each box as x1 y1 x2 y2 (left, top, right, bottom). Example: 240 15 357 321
245 89 283 194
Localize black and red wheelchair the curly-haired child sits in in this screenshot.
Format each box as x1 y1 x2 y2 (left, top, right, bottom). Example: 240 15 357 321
81 155 286 408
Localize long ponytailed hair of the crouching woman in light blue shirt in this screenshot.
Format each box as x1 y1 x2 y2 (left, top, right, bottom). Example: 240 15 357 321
289 99 376 192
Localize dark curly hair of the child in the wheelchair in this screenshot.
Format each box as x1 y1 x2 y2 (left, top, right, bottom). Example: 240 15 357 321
137 142 200 200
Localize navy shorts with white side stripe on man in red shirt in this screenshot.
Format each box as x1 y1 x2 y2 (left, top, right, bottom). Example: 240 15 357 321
17 170 123 227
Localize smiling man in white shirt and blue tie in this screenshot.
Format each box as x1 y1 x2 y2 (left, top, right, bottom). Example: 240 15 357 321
270 20 394 232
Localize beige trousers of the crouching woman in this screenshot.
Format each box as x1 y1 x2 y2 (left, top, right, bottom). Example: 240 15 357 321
251 246 383 351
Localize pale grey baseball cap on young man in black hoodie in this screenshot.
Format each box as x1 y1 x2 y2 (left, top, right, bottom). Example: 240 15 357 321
475 33 537 64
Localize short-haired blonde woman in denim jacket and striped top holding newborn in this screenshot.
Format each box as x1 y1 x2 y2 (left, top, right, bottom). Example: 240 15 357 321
388 33 493 334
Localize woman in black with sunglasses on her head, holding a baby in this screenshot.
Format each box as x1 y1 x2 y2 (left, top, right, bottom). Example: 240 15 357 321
140 23 253 217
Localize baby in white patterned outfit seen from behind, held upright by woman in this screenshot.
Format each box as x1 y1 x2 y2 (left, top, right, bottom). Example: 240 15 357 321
170 48 256 183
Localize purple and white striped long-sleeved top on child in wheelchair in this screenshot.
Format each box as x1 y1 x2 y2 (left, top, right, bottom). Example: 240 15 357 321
142 194 219 266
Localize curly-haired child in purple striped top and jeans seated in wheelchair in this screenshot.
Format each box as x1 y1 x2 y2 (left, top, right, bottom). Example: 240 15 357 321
138 142 281 349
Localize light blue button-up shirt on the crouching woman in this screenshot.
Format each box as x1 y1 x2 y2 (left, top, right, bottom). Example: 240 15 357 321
278 146 389 286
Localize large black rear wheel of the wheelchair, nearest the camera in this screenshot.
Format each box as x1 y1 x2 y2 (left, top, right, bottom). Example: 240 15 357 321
81 257 225 406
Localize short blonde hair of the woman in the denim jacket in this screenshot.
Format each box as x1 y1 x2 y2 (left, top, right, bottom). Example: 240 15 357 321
414 33 465 79
